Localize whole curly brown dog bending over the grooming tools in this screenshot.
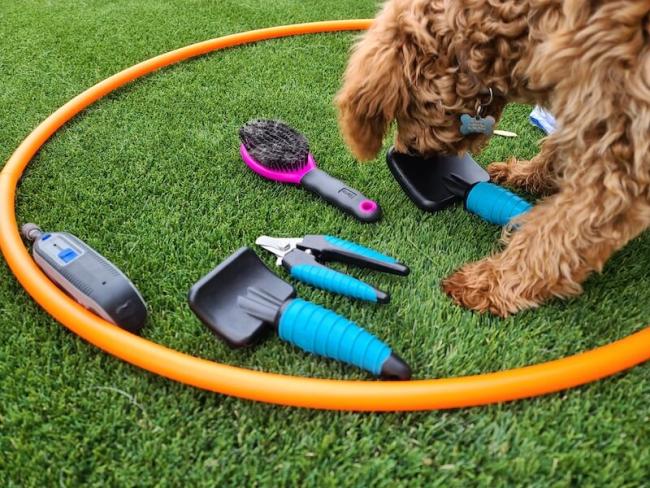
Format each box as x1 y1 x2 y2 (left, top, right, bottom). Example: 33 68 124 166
337 0 650 316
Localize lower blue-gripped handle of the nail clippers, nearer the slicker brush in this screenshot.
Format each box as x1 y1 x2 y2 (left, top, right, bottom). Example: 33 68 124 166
291 264 378 303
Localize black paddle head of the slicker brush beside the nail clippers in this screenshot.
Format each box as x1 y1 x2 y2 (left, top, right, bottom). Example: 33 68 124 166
188 247 295 347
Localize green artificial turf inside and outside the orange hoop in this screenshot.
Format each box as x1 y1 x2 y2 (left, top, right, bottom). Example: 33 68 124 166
0 0 650 486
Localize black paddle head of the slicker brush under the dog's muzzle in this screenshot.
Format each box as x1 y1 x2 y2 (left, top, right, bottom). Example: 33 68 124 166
386 148 490 212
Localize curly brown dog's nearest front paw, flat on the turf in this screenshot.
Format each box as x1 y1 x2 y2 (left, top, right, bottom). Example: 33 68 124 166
442 258 537 317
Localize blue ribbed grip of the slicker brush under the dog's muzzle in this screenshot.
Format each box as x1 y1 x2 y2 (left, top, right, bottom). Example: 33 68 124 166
465 182 533 225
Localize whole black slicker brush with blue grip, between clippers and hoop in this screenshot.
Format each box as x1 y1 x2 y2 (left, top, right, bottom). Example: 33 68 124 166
189 247 411 380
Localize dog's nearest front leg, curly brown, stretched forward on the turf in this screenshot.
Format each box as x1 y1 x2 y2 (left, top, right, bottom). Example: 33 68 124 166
442 180 650 317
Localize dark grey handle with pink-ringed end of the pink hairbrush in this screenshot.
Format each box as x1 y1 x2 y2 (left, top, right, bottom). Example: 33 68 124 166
300 168 381 222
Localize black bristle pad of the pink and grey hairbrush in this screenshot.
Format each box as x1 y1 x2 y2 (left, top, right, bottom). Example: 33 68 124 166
239 119 309 171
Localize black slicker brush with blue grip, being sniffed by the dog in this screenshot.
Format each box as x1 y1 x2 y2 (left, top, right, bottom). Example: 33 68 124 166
386 149 532 226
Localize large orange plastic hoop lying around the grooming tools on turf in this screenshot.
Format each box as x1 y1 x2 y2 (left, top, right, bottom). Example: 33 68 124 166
0 20 650 411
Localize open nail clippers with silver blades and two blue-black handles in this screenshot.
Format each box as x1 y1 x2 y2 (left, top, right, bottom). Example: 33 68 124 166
255 235 409 303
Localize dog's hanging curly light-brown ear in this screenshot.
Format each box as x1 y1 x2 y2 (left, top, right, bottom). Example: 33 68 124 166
336 30 406 160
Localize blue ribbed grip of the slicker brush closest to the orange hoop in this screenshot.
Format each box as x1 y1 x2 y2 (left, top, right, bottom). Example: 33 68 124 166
278 298 392 375
